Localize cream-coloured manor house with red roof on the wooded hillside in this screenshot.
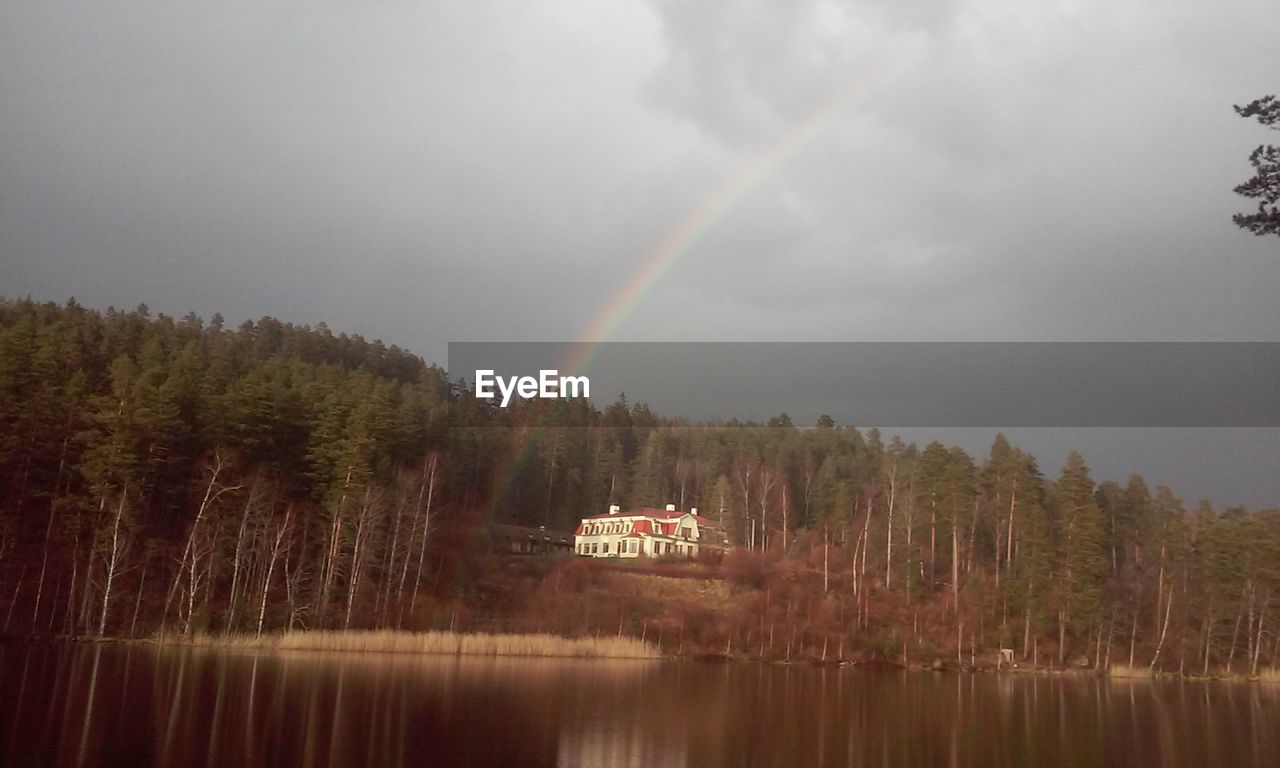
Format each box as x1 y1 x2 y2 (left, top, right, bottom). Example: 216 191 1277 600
573 504 723 557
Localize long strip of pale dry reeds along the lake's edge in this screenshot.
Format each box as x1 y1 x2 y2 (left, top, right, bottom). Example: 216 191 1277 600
152 630 662 659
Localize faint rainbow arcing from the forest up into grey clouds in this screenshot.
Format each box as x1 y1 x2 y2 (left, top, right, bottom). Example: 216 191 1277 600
483 36 925 517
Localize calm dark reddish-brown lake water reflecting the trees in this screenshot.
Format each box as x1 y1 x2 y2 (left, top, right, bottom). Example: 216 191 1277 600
0 644 1280 768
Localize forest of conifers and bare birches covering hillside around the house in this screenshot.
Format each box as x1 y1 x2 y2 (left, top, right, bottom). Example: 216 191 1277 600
0 300 1280 675
